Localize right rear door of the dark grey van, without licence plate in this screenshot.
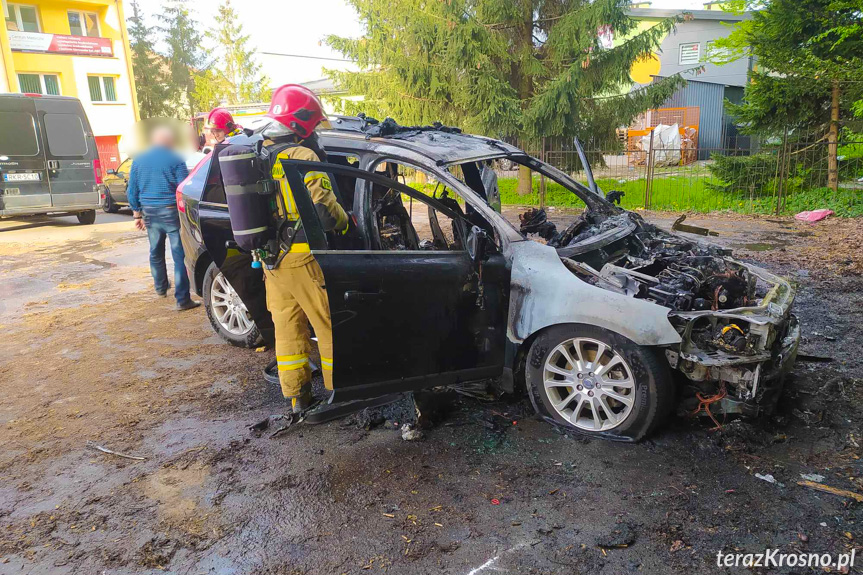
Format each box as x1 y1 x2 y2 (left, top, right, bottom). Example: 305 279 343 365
35 98 99 210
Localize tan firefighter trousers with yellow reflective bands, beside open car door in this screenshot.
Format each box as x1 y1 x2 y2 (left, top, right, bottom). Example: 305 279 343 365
264 254 333 398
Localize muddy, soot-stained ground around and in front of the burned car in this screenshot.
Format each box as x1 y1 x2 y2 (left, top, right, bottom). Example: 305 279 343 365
0 209 863 575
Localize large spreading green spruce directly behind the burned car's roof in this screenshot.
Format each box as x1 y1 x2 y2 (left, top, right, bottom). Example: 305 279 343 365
326 0 682 158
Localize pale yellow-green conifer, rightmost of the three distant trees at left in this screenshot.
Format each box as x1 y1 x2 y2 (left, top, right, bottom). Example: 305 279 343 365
195 0 270 105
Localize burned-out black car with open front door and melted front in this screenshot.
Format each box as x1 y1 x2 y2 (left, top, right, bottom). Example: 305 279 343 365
191 117 800 441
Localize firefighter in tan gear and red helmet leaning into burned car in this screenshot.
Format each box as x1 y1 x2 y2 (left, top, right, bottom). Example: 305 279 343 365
263 84 348 413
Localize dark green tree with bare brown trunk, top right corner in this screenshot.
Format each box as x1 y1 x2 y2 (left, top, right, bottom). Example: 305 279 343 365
726 0 863 191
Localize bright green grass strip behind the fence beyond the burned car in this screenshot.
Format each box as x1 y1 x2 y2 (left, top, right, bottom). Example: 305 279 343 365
498 176 863 217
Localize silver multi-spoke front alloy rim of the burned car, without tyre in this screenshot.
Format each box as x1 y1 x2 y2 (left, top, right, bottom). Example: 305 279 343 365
543 337 635 431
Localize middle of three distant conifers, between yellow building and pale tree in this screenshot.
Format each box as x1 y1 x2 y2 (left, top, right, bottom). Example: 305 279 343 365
158 0 205 117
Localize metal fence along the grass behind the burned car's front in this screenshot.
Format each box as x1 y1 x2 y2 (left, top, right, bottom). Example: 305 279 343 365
506 138 863 216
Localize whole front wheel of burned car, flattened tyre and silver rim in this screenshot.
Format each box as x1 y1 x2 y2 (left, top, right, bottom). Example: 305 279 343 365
525 324 675 441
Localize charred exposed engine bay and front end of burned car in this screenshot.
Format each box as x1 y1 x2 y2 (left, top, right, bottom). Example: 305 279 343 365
519 207 799 416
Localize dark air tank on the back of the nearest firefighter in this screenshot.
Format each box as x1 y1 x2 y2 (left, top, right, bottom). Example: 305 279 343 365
218 144 279 268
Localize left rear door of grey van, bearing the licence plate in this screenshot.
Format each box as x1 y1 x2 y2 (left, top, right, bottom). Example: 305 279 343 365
0 96 51 215
